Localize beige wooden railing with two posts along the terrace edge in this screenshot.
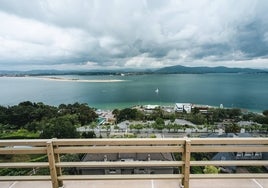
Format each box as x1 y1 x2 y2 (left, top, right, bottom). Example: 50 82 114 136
0 138 268 188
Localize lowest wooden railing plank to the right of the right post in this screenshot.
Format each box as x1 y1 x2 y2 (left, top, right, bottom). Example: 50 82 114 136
190 173 268 179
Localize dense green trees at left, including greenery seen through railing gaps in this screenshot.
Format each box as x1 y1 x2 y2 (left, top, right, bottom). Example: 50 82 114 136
0 101 97 176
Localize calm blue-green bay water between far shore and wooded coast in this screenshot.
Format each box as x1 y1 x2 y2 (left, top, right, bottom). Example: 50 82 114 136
0 74 268 111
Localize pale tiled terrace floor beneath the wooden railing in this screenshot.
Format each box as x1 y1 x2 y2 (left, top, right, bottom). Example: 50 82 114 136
0 179 268 188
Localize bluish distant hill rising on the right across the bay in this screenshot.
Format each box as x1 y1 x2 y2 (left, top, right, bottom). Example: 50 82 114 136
155 65 268 74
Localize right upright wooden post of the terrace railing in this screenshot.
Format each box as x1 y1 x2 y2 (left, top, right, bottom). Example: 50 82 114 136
182 138 191 188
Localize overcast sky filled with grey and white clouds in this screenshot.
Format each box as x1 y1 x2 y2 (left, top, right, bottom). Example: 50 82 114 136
0 0 268 70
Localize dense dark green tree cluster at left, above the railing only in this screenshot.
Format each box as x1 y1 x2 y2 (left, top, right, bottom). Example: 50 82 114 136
0 101 97 139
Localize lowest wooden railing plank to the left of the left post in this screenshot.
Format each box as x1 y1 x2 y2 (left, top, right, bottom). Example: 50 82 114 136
0 176 51 181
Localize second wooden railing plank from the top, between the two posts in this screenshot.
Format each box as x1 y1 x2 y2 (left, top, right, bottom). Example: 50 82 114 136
54 146 183 154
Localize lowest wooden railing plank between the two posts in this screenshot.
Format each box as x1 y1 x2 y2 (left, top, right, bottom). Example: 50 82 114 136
58 174 183 180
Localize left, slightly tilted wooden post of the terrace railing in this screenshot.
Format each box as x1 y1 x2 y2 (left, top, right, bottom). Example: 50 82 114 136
47 140 62 188
